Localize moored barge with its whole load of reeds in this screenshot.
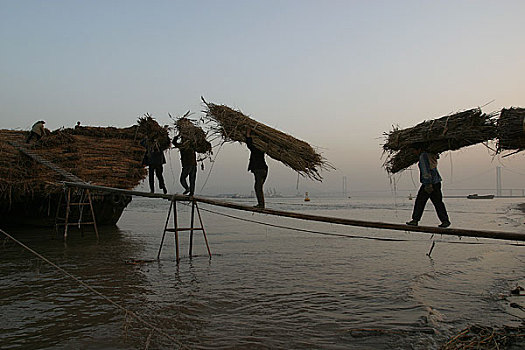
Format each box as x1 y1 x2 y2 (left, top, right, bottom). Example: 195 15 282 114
0 123 154 226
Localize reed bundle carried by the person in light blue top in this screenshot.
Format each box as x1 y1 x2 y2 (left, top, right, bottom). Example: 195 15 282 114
383 108 496 174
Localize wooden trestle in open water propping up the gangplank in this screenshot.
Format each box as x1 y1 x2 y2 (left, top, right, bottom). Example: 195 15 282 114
157 198 211 264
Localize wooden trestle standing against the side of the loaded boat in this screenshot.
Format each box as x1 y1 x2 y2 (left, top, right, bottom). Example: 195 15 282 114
55 187 99 240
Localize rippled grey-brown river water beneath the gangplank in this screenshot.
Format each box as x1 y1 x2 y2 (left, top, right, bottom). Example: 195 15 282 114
0 197 525 349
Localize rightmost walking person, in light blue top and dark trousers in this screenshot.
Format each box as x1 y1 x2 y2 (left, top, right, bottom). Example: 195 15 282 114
406 144 450 227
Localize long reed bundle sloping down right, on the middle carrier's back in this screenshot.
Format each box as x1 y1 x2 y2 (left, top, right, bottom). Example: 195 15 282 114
203 99 333 181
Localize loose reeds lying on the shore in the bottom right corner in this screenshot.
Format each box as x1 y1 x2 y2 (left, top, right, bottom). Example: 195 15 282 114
441 325 525 350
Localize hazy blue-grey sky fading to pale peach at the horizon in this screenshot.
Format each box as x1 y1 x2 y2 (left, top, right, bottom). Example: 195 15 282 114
0 0 525 195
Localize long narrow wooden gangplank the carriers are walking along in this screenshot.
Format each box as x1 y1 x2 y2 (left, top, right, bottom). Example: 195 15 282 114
64 182 525 241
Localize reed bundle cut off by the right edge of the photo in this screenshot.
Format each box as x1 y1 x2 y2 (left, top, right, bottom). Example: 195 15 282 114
498 108 525 152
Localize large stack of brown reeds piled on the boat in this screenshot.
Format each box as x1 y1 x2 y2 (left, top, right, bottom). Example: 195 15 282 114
0 127 146 202
